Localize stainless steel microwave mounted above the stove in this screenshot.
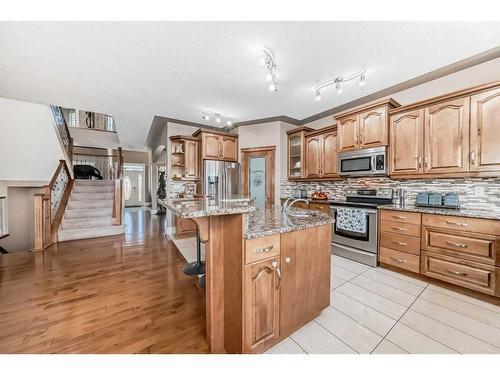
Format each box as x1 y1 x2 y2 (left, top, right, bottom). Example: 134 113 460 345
337 146 387 176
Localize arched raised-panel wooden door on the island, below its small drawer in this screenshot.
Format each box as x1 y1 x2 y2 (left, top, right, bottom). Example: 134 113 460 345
243 257 280 353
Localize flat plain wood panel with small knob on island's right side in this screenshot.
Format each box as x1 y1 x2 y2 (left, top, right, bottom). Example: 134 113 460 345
280 225 332 339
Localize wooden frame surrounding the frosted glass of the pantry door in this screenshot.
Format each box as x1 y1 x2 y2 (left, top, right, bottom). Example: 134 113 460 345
240 146 276 207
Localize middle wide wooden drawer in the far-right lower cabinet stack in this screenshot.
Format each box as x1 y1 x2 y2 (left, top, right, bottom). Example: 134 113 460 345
422 227 499 265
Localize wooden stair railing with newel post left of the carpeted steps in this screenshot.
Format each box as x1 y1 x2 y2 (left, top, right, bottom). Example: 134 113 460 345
34 160 74 251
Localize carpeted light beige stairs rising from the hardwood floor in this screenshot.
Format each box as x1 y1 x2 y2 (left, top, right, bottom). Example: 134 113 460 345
58 179 124 241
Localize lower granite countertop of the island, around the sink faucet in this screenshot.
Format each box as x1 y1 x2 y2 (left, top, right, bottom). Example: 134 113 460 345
244 207 333 239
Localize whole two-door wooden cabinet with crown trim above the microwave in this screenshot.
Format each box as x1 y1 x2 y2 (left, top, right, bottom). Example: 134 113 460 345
335 98 399 152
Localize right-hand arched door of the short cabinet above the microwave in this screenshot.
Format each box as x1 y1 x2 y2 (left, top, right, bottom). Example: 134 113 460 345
359 107 388 148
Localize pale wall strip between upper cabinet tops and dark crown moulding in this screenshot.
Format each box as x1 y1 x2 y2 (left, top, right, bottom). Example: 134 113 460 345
304 58 500 129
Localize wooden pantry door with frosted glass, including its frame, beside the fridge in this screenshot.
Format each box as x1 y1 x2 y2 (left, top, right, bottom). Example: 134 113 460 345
241 146 276 208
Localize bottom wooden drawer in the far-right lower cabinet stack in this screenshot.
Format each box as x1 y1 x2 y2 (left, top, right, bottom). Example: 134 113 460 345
421 251 499 295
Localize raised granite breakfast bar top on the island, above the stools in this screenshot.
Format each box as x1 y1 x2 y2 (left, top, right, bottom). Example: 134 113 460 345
158 198 255 218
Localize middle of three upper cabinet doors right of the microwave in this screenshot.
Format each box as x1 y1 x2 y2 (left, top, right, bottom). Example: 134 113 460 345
424 97 470 173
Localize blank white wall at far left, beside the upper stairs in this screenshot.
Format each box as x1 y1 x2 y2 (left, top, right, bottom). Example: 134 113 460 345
0 98 64 181
